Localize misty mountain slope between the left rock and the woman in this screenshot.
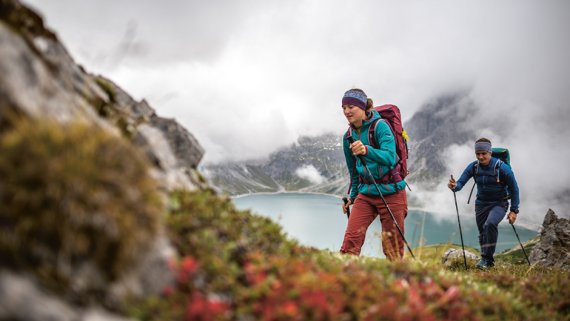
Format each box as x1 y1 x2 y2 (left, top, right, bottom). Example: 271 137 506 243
201 133 348 195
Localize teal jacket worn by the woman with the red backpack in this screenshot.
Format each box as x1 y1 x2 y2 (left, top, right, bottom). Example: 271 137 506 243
342 110 406 199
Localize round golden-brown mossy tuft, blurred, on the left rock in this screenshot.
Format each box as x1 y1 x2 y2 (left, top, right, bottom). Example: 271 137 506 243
0 120 163 292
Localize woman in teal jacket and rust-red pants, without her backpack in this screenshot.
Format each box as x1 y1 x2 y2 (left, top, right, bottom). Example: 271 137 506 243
340 89 408 260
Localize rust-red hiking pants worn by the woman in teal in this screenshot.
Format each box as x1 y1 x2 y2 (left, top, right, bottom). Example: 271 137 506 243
340 189 408 260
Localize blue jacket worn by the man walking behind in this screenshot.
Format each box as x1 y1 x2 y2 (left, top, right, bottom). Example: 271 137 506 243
455 157 520 210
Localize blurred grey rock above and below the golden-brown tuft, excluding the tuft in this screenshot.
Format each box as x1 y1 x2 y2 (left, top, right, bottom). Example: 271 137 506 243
0 0 208 320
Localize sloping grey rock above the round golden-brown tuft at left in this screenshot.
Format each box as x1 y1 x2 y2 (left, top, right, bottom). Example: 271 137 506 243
0 0 204 190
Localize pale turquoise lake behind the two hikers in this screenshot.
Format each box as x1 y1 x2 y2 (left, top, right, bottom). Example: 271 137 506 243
233 193 538 257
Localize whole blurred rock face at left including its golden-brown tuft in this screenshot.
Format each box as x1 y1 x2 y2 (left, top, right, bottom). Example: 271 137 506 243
0 0 207 320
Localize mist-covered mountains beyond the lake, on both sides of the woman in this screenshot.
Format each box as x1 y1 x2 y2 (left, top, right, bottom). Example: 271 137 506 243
201 90 570 226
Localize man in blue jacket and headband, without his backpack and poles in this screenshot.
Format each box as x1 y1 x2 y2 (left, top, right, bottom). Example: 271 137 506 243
447 138 520 269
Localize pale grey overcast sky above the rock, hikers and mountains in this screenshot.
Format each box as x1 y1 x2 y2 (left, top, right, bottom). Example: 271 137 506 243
22 0 570 222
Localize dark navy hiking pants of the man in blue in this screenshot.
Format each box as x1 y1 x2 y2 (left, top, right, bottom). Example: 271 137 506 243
475 202 509 263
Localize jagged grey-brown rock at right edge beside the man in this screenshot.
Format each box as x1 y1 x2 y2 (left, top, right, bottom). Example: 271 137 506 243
529 209 570 270
